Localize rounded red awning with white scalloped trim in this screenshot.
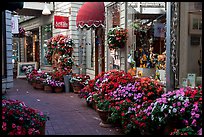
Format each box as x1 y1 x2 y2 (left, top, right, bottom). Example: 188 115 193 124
76 2 105 28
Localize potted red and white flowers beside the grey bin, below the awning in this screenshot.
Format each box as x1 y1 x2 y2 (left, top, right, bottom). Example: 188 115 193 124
70 73 90 93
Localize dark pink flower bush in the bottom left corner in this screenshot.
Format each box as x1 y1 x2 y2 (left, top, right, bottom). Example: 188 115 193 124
1 99 48 136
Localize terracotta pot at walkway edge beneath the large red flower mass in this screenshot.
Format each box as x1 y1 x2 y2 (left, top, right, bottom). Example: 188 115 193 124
97 109 112 127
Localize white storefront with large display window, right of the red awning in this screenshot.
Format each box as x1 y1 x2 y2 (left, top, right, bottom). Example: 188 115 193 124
105 2 202 89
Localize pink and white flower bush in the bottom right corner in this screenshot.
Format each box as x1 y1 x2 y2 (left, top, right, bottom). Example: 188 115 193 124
149 87 202 134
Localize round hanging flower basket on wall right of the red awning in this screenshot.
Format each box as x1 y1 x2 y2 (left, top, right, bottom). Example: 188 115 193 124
107 27 127 49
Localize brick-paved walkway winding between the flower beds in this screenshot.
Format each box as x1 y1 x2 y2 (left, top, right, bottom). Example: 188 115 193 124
5 79 122 135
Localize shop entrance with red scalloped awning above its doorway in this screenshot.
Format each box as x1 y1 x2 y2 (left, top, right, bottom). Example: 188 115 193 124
76 2 105 78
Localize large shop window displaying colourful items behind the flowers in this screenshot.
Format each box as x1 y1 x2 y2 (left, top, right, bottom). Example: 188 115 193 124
127 2 166 79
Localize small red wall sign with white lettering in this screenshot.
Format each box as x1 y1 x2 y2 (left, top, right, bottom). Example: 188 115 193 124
54 16 69 29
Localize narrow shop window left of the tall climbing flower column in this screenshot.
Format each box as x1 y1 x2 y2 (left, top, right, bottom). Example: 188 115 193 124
41 24 52 66
